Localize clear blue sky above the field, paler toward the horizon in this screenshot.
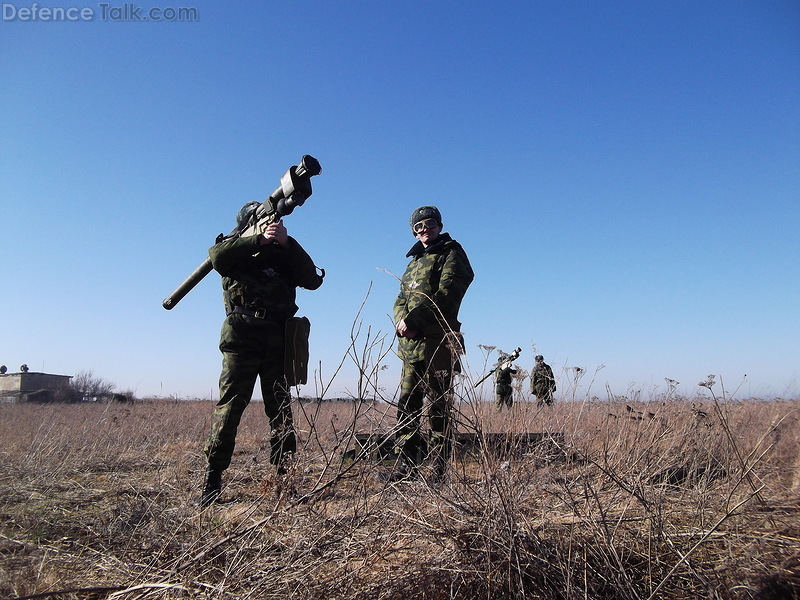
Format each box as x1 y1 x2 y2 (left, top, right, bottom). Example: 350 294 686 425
0 0 800 398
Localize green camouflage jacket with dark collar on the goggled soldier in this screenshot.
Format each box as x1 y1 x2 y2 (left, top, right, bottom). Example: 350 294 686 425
394 233 474 362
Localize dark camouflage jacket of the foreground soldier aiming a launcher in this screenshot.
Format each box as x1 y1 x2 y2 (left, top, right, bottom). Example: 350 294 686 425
208 235 322 321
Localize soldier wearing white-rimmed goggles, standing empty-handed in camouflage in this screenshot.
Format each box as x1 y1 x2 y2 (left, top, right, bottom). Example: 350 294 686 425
391 206 474 480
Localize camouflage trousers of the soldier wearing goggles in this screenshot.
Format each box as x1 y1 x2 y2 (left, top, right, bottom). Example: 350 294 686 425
395 358 453 465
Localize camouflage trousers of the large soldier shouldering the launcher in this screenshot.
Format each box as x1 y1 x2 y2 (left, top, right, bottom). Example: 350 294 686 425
204 315 297 471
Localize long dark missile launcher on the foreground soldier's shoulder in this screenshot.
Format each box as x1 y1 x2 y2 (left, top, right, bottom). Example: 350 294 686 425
161 154 322 310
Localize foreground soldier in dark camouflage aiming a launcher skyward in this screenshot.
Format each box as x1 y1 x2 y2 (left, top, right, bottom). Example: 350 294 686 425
198 203 324 506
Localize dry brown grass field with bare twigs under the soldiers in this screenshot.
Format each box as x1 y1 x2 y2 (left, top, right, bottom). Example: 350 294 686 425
0 394 800 600
